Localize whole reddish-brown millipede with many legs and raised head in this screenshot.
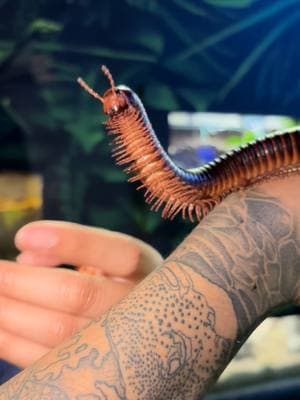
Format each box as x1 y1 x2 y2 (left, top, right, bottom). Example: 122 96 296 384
78 66 300 221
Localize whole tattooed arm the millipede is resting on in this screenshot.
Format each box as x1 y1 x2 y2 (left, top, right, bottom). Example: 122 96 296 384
0 177 300 400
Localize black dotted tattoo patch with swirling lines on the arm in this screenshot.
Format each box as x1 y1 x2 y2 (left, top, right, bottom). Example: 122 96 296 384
99 262 231 400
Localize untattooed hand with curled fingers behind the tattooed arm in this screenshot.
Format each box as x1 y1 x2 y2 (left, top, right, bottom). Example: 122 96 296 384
0 221 162 367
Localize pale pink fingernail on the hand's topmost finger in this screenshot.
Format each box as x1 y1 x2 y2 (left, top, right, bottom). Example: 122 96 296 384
15 227 58 250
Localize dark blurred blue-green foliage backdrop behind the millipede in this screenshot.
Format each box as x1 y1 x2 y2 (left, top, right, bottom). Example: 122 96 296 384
0 0 300 253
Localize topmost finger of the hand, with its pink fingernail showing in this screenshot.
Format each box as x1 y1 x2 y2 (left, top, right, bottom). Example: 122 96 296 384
15 221 145 276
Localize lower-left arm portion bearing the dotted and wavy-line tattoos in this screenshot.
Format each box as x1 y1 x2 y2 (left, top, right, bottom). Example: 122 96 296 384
0 262 232 400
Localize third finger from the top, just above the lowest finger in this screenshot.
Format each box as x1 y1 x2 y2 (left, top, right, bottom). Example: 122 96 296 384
0 296 90 347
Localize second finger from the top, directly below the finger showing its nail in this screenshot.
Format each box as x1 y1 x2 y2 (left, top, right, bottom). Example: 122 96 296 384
0 261 135 318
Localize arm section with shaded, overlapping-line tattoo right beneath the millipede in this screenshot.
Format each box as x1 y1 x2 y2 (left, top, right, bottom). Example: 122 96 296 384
170 190 300 336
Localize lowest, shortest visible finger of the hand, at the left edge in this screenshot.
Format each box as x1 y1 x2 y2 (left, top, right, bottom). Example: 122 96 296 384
0 329 50 368
